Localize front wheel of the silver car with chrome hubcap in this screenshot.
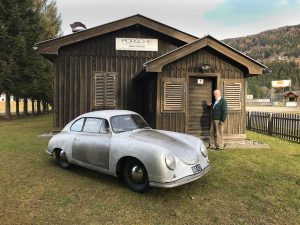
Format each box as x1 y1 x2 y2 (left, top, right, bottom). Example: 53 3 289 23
123 159 149 193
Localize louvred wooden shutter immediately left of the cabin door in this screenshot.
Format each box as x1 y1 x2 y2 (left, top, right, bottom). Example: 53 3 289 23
163 81 184 111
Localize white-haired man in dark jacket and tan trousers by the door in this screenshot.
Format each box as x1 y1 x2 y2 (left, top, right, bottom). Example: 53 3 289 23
209 90 227 150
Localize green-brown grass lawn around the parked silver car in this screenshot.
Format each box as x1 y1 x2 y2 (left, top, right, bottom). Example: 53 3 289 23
0 115 300 225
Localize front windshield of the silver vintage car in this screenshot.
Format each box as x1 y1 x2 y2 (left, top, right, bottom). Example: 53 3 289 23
110 114 150 133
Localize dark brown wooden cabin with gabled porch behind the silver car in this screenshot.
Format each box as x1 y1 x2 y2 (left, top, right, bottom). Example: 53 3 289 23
37 15 266 142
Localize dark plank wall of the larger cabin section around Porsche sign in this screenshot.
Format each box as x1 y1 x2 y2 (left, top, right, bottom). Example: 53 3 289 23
54 25 185 129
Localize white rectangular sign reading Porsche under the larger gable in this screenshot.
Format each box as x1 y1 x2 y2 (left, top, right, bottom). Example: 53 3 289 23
116 38 158 52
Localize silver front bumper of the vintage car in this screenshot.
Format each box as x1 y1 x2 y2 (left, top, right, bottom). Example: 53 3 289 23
149 165 210 188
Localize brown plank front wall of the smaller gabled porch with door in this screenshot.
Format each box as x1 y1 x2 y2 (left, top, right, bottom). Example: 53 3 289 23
156 47 247 134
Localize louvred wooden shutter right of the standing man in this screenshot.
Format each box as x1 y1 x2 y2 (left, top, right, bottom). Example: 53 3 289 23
224 83 241 110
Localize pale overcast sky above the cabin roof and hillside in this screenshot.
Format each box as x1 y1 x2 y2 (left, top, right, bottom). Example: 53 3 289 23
57 0 300 40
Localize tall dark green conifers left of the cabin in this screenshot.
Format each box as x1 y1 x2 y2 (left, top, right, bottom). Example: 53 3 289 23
0 0 61 118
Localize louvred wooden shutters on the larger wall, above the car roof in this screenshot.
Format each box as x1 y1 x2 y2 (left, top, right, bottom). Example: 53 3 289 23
94 72 117 108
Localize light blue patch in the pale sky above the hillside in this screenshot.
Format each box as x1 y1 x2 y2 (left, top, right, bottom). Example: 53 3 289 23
203 0 300 26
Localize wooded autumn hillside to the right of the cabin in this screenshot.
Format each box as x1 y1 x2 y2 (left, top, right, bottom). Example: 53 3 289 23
223 24 300 98
